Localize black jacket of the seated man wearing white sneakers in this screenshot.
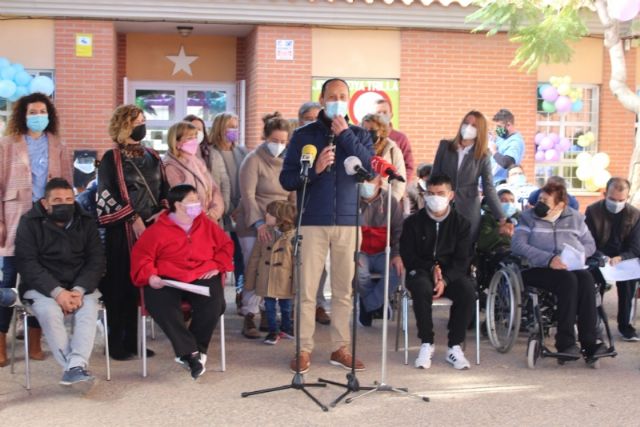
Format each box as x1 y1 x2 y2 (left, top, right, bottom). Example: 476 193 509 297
400 208 471 284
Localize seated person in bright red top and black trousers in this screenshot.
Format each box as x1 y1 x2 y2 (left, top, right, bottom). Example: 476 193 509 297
131 184 233 380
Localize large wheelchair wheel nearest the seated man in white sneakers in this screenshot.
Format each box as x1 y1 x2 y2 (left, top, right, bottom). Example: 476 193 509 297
486 265 522 353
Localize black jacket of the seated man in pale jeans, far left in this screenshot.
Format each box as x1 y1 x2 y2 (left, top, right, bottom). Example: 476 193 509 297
15 202 105 297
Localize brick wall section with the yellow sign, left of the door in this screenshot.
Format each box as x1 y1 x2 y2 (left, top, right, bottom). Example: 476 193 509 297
55 20 117 157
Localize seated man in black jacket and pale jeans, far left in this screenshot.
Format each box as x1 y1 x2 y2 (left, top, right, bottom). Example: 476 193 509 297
16 178 105 386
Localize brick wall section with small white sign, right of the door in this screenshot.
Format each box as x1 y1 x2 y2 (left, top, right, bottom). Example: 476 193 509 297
243 26 311 148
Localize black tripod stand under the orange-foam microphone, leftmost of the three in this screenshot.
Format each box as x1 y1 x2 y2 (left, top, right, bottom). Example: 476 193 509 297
240 167 329 412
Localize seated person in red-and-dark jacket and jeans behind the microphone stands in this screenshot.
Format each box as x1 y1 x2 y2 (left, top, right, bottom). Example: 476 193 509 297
358 176 404 326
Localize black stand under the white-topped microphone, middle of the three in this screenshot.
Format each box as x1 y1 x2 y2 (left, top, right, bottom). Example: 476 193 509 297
318 177 373 408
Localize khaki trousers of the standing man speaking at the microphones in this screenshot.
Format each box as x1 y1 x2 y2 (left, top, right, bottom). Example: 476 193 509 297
300 226 356 353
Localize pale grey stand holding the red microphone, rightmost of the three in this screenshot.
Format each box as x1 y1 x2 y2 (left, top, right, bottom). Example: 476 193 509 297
345 176 429 403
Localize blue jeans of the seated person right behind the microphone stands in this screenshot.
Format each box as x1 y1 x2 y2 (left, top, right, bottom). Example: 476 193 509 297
358 252 400 311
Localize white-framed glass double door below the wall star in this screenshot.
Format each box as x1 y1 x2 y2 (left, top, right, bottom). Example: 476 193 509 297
127 82 236 153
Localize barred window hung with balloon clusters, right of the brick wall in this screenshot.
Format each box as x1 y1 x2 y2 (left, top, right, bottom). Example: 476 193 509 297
535 84 600 192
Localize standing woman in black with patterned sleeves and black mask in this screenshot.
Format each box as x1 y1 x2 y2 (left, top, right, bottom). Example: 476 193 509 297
97 105 169 360
